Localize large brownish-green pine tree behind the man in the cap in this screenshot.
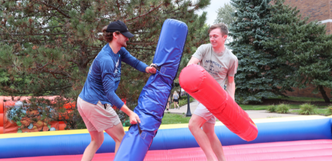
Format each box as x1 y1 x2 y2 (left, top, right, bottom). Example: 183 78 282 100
0 0 210 105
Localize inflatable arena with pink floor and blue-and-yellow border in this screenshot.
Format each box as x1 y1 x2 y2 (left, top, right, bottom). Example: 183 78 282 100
0 116 332 161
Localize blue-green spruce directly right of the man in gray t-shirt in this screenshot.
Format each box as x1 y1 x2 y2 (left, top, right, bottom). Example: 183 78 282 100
230 0 285 103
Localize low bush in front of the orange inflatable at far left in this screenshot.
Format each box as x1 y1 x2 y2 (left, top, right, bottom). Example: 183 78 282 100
7 97 85 132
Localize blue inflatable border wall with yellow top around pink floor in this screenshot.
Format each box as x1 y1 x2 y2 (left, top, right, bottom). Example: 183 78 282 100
0 116 332 158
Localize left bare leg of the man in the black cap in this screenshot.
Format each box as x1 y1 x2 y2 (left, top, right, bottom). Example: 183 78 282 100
82 131 104 161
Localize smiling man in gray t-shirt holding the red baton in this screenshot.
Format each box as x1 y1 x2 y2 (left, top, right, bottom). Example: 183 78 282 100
187 24 238 161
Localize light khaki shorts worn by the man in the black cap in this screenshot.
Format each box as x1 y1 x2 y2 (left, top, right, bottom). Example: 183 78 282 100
77 97 121 132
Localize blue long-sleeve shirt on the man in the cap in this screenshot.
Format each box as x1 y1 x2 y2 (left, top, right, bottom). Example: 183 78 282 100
79 44 148 109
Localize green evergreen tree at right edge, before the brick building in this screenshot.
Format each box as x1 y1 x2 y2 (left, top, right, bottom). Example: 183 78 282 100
263 0 332 103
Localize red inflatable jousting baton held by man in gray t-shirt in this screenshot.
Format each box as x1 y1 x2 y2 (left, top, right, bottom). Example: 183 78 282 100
179 64 258 141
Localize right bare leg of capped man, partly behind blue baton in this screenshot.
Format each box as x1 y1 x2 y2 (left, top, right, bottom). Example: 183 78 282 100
105 123 125 154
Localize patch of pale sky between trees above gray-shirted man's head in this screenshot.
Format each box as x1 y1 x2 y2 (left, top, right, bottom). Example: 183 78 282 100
197 0 230 25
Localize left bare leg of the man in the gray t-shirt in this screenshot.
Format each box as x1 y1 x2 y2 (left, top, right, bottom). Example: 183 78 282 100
189 114 215 161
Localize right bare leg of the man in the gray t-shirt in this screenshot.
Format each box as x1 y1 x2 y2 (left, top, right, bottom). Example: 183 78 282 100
203 122 226 161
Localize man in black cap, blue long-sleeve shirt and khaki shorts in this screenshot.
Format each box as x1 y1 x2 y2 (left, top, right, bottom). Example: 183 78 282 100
77 20 156 160
